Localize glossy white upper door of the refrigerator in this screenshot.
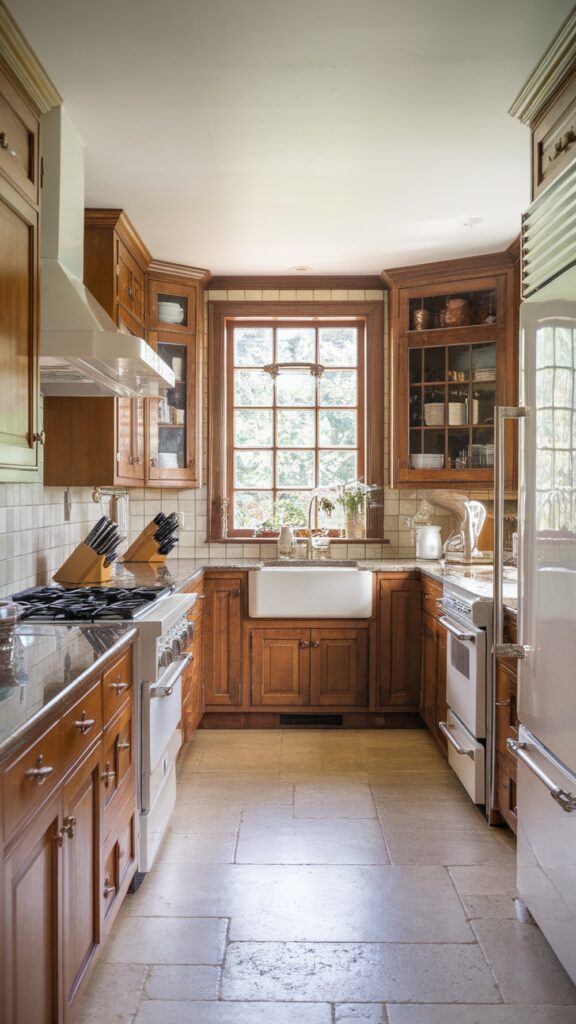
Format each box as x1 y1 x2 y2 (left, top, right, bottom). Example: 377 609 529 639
519 292 576 768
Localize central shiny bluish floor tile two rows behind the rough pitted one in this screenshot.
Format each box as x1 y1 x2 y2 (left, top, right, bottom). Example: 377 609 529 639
236 817 389 864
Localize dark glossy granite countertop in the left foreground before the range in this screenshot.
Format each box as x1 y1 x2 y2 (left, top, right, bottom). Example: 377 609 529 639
0 623 136 757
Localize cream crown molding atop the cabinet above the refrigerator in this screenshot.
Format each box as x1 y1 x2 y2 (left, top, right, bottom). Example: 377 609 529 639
508 7 576 125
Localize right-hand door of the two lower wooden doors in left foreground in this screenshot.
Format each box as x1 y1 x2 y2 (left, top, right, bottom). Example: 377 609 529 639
61 743 100 1007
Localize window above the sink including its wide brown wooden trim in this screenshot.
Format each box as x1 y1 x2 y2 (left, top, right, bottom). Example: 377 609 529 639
208 302 384 540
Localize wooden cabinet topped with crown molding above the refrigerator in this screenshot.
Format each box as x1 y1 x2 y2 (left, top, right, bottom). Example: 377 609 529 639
509 8 576 199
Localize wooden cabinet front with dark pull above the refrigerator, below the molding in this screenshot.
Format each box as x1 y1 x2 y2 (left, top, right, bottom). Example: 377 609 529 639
533 74 576 198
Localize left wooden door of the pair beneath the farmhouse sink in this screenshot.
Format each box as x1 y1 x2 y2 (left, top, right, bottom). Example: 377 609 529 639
250 627 311 707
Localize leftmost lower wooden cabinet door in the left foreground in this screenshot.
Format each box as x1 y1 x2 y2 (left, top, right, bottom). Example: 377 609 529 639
2 793 60 1024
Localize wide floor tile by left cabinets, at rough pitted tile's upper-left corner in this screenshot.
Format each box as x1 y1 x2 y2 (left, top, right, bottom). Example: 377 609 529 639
102 915 228 964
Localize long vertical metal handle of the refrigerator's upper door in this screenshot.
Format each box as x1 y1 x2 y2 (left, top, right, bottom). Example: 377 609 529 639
493 406 527 657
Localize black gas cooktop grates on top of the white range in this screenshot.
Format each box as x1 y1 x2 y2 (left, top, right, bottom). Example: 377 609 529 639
11 586 170 623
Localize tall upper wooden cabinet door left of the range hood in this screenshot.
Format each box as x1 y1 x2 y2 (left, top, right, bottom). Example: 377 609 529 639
0 177 39 481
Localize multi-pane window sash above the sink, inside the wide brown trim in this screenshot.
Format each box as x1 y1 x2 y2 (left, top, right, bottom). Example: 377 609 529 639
227 318 364 536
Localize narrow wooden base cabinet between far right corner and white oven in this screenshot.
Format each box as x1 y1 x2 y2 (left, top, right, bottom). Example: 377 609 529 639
420 575 447 753
